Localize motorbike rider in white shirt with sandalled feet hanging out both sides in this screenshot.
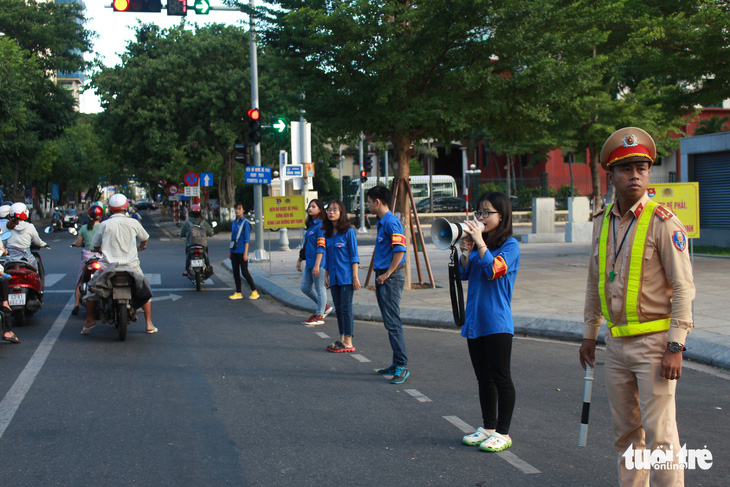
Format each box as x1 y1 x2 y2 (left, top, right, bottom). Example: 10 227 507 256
81 193 158 335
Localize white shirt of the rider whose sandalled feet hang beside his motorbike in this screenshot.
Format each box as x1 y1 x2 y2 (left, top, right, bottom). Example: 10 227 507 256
91 213 150 272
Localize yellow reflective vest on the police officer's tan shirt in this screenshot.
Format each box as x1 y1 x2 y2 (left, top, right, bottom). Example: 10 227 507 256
598 200 671 337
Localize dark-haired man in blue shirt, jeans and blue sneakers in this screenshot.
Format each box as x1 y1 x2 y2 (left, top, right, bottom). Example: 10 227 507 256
368 186 410 384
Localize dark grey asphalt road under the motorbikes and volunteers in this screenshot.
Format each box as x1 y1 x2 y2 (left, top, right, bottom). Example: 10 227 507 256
0 222 730 487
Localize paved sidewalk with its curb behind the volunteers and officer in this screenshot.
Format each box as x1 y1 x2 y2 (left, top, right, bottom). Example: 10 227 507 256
154 213 730 369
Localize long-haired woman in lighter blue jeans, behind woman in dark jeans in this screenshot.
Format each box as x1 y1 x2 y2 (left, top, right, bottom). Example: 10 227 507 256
297 199 332 325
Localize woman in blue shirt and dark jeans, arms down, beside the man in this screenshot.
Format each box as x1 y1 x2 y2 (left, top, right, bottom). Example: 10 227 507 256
323 201 360 353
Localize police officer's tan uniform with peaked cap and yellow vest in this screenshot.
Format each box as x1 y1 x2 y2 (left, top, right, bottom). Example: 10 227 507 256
583 127 695 486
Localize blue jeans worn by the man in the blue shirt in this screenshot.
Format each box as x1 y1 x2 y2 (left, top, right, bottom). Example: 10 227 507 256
375 269 408 367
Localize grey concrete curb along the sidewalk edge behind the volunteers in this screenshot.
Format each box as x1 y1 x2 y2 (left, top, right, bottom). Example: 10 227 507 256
223 259 730 370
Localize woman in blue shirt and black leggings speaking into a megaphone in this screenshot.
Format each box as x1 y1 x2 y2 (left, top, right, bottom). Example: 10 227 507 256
460 193 520 452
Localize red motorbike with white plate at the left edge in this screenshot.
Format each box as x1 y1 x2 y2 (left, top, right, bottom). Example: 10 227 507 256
2 246 50 326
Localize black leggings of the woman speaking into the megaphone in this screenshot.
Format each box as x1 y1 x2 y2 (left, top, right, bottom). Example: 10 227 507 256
467 333 515 435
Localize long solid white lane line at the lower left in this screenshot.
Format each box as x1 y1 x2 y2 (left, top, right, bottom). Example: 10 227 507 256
0 296 74 438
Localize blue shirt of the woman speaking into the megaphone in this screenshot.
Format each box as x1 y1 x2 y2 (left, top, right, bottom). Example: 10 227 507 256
459 238 520 338
